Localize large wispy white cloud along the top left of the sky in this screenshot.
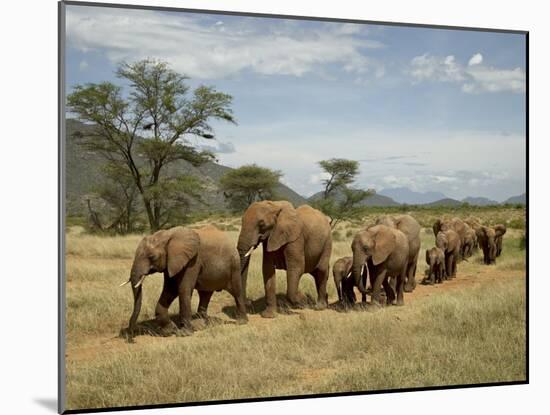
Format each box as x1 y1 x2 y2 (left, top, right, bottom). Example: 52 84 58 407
67 7 383 79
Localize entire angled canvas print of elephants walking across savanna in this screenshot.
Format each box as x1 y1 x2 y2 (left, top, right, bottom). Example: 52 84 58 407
59 2 528 412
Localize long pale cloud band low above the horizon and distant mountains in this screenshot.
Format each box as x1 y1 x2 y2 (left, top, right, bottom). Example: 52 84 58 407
218 120 526 200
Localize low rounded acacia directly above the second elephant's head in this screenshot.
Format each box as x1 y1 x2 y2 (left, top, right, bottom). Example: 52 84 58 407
220 164 282 210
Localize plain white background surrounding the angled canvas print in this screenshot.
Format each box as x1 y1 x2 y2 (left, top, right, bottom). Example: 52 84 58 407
0 0 550 414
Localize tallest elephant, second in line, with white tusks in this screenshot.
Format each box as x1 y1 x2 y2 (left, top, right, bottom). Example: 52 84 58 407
237 200 332 318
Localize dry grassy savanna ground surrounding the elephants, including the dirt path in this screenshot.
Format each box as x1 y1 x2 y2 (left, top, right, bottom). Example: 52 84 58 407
66 207 526 409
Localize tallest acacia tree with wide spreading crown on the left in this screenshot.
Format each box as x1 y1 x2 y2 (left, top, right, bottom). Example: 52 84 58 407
67 59 235 231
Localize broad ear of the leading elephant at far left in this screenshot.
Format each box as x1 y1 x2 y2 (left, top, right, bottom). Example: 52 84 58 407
166 228 200 277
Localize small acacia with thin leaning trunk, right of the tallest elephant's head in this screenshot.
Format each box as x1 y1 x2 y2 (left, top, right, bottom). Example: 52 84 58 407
314 158 374 228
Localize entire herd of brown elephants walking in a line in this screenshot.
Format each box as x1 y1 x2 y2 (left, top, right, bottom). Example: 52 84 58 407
122 201 506 342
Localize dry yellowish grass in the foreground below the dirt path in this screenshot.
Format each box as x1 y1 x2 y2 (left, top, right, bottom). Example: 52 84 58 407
67 280 525 409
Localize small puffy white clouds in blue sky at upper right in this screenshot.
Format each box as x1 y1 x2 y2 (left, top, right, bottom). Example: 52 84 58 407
408 53 525 94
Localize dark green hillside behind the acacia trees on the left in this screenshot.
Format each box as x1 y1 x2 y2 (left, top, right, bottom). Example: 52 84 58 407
65 119 307 216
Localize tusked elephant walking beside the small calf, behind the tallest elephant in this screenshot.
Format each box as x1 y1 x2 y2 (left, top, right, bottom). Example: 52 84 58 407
351 225 409 306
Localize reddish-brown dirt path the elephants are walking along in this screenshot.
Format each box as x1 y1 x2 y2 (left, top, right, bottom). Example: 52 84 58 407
65 266 525 366
